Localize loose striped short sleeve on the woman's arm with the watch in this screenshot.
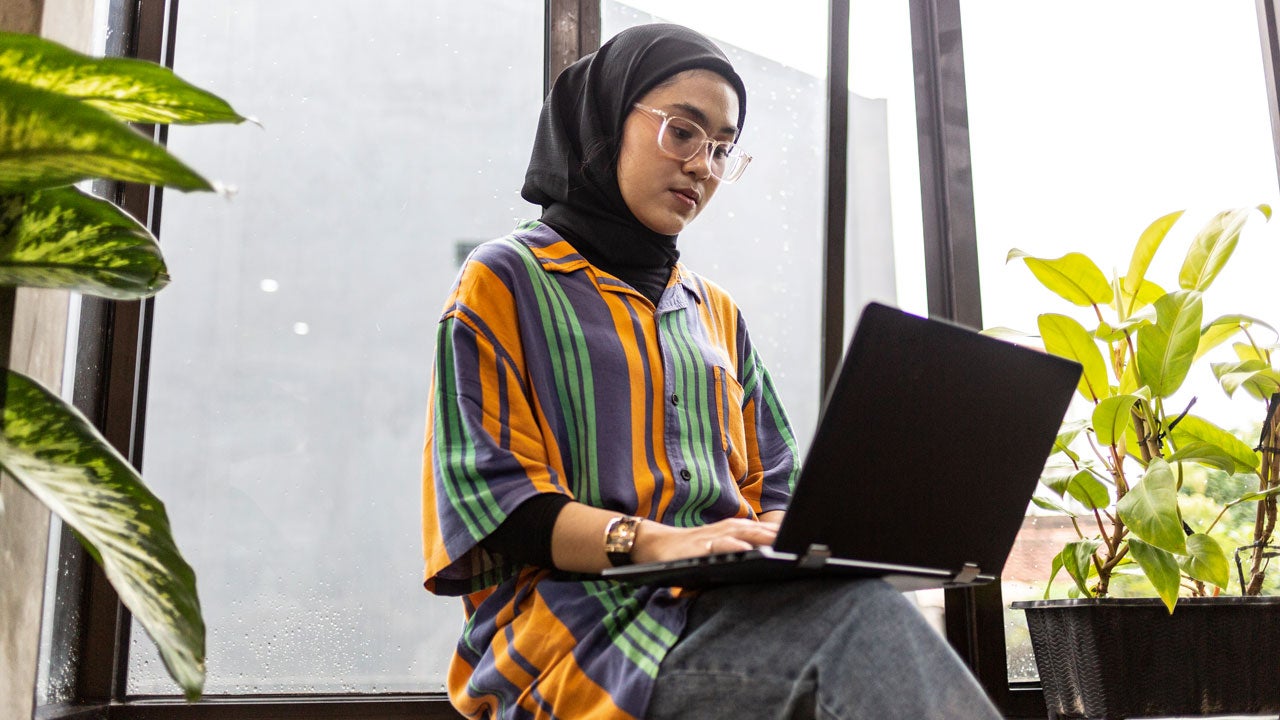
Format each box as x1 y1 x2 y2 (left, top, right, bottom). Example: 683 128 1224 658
422 245 567 594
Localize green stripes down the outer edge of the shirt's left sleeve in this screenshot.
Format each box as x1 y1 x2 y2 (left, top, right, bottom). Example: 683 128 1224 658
435 319 504 541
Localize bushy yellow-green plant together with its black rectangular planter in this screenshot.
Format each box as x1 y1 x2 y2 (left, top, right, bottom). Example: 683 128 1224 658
987 205 1280 717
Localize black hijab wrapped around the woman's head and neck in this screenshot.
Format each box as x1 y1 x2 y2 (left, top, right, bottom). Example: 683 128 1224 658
520 24 746 304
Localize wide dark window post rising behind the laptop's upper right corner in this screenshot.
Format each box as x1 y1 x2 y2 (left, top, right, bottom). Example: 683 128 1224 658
910 0 982 328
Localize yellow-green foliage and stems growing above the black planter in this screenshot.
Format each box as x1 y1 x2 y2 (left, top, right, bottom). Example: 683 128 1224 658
987 205 1280 612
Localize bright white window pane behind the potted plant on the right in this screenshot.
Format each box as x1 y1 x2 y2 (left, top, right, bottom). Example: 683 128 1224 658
961 0 1280 696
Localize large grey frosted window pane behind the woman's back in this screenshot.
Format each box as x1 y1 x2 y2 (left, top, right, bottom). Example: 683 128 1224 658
128 0 543 694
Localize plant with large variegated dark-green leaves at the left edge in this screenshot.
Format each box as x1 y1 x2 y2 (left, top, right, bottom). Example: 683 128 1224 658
0 33 244 700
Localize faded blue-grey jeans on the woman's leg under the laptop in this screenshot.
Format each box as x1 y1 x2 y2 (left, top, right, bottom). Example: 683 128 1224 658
649 579 1000 720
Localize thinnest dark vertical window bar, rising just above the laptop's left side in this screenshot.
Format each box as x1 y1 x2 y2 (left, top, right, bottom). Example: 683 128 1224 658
818 0 849 392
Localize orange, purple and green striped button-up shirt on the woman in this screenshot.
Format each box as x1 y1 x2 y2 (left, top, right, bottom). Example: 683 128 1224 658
422 222 799 720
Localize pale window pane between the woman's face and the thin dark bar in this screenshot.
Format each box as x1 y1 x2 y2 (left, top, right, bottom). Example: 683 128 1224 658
602 0 827 443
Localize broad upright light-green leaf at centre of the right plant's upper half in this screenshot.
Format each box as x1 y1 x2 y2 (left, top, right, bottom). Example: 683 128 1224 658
1138 291 1203 397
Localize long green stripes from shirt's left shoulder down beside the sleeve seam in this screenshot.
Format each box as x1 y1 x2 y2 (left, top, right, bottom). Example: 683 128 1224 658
506 237 603 506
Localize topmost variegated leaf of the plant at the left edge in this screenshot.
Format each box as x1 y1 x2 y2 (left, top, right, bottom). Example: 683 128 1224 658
0 32 244 124
